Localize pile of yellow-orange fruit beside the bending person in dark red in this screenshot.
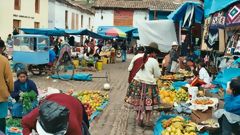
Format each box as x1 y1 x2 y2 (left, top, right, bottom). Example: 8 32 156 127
77 91 108 120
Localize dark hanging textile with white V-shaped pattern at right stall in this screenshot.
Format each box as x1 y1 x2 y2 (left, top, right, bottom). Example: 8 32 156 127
205 28 219 48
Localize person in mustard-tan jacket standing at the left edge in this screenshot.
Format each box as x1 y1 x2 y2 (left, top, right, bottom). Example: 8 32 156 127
0 40 13 132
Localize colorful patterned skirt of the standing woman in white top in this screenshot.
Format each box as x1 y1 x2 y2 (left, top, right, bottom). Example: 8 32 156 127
126 80 160 110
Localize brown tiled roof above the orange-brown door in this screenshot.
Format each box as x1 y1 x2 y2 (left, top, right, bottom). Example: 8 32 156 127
93 0 202 11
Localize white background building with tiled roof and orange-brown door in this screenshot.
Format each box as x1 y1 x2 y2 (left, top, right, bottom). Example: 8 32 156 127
93 0 180 29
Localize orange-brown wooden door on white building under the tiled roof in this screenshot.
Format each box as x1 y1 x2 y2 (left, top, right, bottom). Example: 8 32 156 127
114 10 133 26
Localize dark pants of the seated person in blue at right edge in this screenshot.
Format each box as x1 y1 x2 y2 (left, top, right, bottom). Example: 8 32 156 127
214 115 240 135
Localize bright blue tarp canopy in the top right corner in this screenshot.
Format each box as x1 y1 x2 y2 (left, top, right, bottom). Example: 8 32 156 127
204 0 239 17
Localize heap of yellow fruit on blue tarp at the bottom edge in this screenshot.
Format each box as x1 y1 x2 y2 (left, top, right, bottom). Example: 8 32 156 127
161 116 197 135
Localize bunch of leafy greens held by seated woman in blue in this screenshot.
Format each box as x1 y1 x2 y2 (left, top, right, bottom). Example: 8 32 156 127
20 90 37 113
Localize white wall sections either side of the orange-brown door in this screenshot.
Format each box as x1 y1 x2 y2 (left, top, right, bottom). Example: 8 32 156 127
94 10 149 31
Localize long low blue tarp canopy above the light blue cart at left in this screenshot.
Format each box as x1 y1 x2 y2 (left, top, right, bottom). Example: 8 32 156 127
20 28 111 39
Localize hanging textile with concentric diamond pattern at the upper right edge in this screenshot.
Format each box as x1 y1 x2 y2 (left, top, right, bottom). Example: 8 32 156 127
226 4 240 26
